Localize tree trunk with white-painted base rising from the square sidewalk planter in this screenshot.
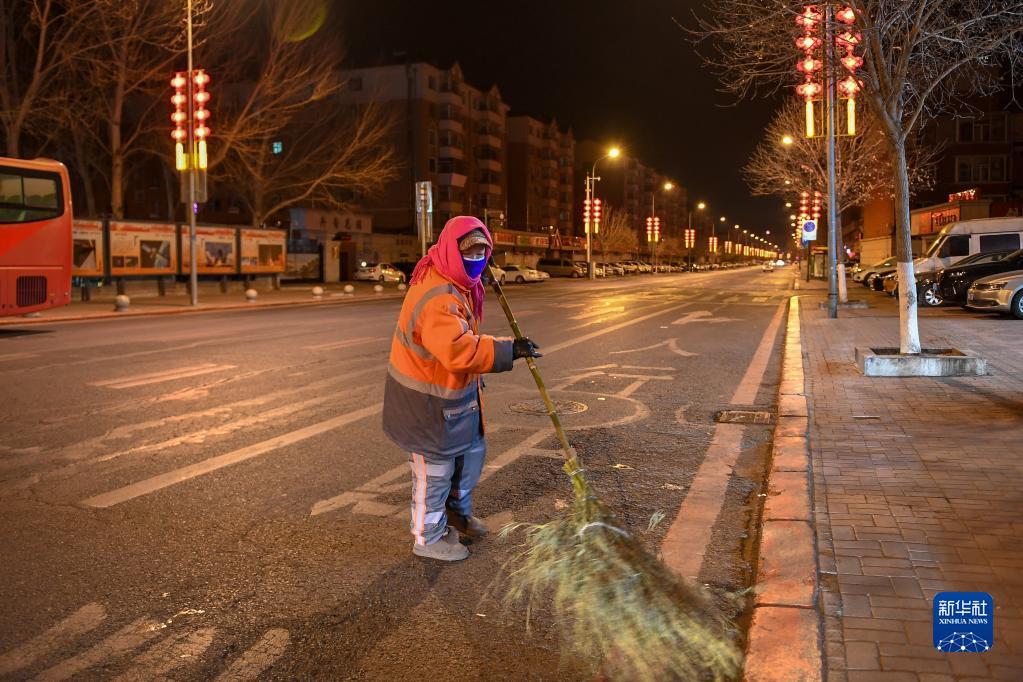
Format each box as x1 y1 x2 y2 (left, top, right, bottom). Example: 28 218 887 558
892 139 920 355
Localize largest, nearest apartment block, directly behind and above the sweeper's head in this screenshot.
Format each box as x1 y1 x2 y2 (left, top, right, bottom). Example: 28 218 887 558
341 62 509 232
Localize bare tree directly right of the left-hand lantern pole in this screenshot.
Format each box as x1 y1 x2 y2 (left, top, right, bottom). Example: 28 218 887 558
203 2 398 225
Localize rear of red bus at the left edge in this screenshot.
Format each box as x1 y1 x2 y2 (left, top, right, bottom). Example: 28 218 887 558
0 156 72 316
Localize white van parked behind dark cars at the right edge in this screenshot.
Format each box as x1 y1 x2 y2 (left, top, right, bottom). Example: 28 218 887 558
913 218 1023 272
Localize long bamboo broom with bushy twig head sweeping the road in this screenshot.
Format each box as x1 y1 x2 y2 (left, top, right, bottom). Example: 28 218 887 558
488 262 742 680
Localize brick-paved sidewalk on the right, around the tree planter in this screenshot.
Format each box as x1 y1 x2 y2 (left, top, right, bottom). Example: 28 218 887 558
797 282 1023 682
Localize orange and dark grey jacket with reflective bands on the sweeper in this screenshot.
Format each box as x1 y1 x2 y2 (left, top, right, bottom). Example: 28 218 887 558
384 270 514 456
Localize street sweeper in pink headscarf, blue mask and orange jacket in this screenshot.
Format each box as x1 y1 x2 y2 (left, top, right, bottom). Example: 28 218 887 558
384 216 540 561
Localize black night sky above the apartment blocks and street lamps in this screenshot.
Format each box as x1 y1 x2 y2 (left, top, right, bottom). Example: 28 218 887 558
330 0 789 244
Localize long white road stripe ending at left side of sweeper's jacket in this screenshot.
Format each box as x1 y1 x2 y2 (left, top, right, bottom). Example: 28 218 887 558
82 403 384 508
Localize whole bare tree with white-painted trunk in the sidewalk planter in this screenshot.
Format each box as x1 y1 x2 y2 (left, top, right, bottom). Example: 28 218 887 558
699 0 1023 354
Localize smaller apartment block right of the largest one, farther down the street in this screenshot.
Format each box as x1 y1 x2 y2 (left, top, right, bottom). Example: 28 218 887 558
507 116 575 235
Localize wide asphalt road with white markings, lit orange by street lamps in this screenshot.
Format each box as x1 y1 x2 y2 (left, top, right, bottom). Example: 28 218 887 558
0 269 793 680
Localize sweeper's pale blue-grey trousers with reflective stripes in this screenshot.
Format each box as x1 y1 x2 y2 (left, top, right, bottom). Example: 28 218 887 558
408 438 487 545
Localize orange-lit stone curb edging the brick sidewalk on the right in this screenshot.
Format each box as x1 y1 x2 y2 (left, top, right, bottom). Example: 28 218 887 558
744 295 824 682
